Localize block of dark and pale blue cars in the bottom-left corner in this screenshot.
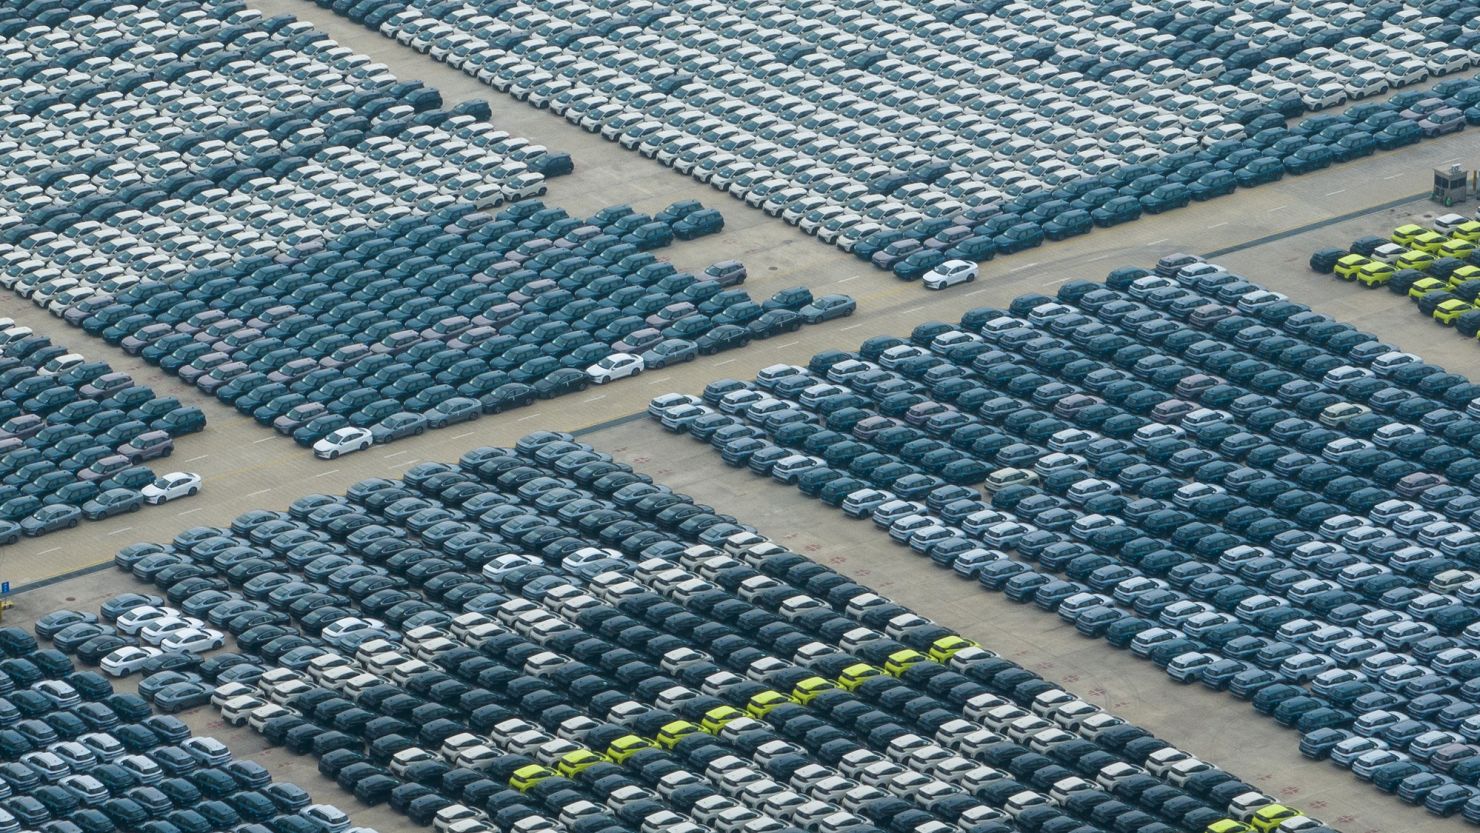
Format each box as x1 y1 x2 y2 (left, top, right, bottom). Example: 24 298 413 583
18 603 374 833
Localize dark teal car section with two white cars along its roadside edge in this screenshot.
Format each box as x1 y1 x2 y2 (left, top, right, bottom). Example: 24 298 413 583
63 189 855 456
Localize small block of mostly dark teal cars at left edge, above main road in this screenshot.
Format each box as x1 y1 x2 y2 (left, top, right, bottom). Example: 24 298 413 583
0 318 206 544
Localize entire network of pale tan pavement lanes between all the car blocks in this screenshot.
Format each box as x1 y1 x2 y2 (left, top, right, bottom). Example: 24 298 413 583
0 0 1480 833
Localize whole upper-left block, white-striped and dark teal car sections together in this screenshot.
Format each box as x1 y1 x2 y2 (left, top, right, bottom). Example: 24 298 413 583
0 3 854 457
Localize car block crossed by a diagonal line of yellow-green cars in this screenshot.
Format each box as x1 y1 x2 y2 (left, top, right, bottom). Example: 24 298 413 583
92 432 1302 833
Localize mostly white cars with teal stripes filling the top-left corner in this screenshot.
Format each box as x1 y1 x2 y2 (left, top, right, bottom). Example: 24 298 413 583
0 1 568 322
